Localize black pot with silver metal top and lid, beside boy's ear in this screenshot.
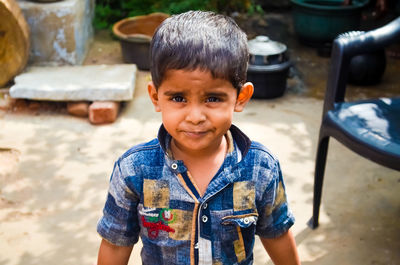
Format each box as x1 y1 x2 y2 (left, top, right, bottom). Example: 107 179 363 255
247 36 292 99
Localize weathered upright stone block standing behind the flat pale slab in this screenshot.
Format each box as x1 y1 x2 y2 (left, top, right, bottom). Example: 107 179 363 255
18 0 95 65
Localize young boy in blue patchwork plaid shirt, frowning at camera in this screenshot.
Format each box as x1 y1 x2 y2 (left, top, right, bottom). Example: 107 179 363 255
97 11 299 265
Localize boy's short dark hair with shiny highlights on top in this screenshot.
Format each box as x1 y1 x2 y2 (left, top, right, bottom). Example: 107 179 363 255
150 11 249 91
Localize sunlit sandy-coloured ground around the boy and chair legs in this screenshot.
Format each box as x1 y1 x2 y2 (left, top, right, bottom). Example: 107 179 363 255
0 11 400 265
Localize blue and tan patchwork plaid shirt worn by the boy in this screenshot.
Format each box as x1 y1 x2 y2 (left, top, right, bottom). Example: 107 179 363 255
97 125 294 265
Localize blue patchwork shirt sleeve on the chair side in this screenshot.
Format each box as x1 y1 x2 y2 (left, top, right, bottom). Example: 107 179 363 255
256 162 294 238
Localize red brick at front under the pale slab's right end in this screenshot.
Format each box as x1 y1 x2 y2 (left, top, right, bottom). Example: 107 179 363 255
89 101 120 124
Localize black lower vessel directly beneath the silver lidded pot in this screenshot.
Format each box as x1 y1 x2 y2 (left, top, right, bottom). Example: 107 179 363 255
247 61 292 99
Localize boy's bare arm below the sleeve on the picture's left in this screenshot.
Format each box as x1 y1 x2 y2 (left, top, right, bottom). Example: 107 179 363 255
97 239 133 265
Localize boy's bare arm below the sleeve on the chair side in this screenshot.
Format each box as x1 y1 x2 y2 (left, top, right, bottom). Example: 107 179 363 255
260 230 300 265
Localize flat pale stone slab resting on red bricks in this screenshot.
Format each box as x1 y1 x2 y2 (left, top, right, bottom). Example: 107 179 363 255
10 64 137 101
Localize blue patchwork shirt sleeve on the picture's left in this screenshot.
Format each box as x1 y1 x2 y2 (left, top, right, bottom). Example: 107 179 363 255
97 161 140 246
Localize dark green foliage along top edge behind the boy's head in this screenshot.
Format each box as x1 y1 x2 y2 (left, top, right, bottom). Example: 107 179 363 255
93 0 261 29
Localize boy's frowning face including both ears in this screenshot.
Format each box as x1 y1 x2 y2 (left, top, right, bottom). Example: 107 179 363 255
148 70 253 154
